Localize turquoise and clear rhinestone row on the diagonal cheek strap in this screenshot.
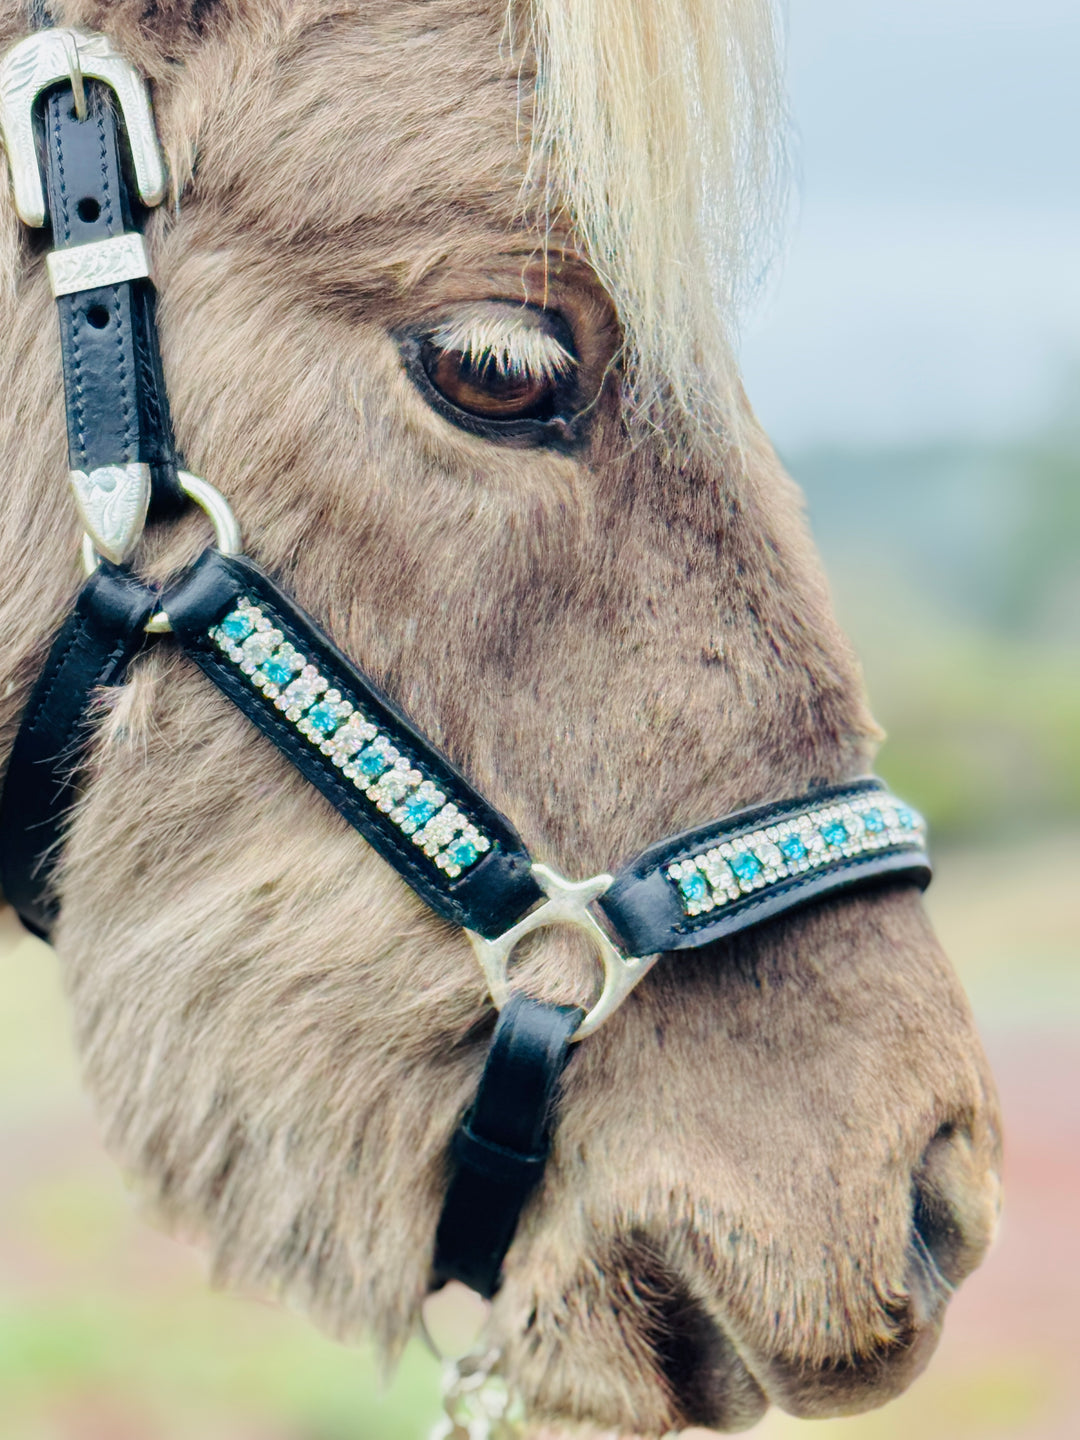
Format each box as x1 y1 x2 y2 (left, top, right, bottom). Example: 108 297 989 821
210 599 491 880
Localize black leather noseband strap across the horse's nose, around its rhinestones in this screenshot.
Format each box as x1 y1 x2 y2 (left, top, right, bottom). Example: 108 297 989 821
598 779 932 955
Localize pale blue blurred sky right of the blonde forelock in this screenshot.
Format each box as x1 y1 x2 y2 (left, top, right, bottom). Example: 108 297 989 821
743 0 1080 452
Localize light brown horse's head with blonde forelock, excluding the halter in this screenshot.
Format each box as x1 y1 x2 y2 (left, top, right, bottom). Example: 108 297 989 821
0 0 999 1436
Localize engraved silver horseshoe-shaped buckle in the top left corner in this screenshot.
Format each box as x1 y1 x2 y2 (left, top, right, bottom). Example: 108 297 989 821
0 30 166 228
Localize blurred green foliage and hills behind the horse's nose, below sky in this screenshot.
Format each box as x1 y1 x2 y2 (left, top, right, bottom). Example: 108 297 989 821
791 386 1080 840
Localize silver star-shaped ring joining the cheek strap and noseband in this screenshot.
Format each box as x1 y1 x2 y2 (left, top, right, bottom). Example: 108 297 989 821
465 865 660 1040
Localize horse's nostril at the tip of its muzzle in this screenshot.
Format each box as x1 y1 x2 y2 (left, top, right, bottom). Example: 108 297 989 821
912 1123 998 1299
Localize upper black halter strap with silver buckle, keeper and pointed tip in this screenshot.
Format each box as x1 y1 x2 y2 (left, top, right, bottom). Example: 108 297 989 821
0 29 184 563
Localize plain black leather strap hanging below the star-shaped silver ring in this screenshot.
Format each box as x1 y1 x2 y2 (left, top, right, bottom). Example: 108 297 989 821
433 995 583 1299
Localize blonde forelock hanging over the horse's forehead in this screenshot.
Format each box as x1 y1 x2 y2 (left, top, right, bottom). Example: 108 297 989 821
530 0 788 439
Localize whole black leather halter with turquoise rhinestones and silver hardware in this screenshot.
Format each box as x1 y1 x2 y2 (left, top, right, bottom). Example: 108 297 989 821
0 30 930 1319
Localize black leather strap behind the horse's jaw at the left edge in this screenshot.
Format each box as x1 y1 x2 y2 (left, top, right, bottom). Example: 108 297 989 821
0 564 157 936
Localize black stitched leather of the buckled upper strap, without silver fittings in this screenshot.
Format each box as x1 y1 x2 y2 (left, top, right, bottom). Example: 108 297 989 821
43 79 184 514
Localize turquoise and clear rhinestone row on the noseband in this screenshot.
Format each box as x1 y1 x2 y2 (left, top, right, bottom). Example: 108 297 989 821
667 792 926 914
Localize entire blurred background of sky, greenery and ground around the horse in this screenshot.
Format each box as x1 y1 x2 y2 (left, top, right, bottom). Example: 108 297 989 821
0 0 1080 1440
